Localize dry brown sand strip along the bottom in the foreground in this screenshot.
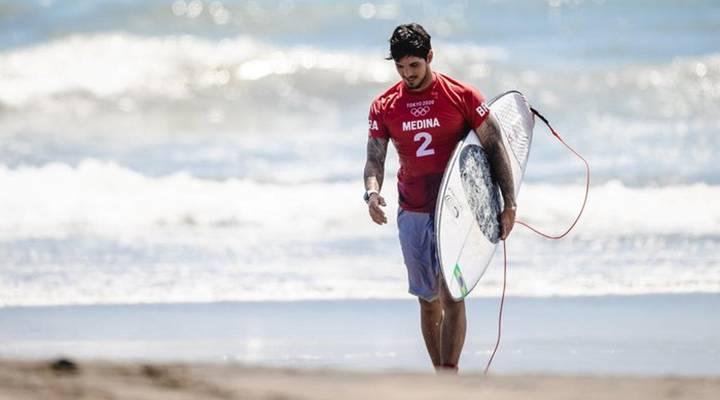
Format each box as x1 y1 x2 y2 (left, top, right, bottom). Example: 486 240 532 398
0 361 720 400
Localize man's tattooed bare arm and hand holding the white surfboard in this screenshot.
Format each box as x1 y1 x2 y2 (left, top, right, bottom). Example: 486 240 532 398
475 114 516 240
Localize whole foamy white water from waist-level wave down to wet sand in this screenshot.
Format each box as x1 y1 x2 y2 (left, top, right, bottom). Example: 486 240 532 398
0 160 720 305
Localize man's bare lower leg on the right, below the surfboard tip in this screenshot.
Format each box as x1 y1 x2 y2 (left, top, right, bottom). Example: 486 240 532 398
440 280 467 372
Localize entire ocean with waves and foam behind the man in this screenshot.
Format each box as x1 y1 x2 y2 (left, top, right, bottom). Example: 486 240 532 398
0 0 720 306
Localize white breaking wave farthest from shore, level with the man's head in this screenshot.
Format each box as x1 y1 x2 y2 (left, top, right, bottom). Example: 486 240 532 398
0 32 720 109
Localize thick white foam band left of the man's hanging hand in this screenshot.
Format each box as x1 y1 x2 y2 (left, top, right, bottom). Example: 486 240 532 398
0 160 360 236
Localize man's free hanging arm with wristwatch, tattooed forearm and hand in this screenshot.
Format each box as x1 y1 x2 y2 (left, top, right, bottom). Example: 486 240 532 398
364 137 388 225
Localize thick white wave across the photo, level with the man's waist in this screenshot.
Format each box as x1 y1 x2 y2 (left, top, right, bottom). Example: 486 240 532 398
0 160 720 238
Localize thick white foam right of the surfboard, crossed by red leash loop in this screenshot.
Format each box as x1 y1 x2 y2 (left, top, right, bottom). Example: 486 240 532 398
518 181 720 235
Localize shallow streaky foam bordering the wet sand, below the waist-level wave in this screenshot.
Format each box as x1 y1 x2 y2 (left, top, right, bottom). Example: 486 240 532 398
0 228 720 306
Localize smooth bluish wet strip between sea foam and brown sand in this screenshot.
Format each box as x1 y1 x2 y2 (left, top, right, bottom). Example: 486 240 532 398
0 294 720 377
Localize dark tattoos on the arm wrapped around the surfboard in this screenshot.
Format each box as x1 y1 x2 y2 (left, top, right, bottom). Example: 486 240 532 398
476 115 515 207
